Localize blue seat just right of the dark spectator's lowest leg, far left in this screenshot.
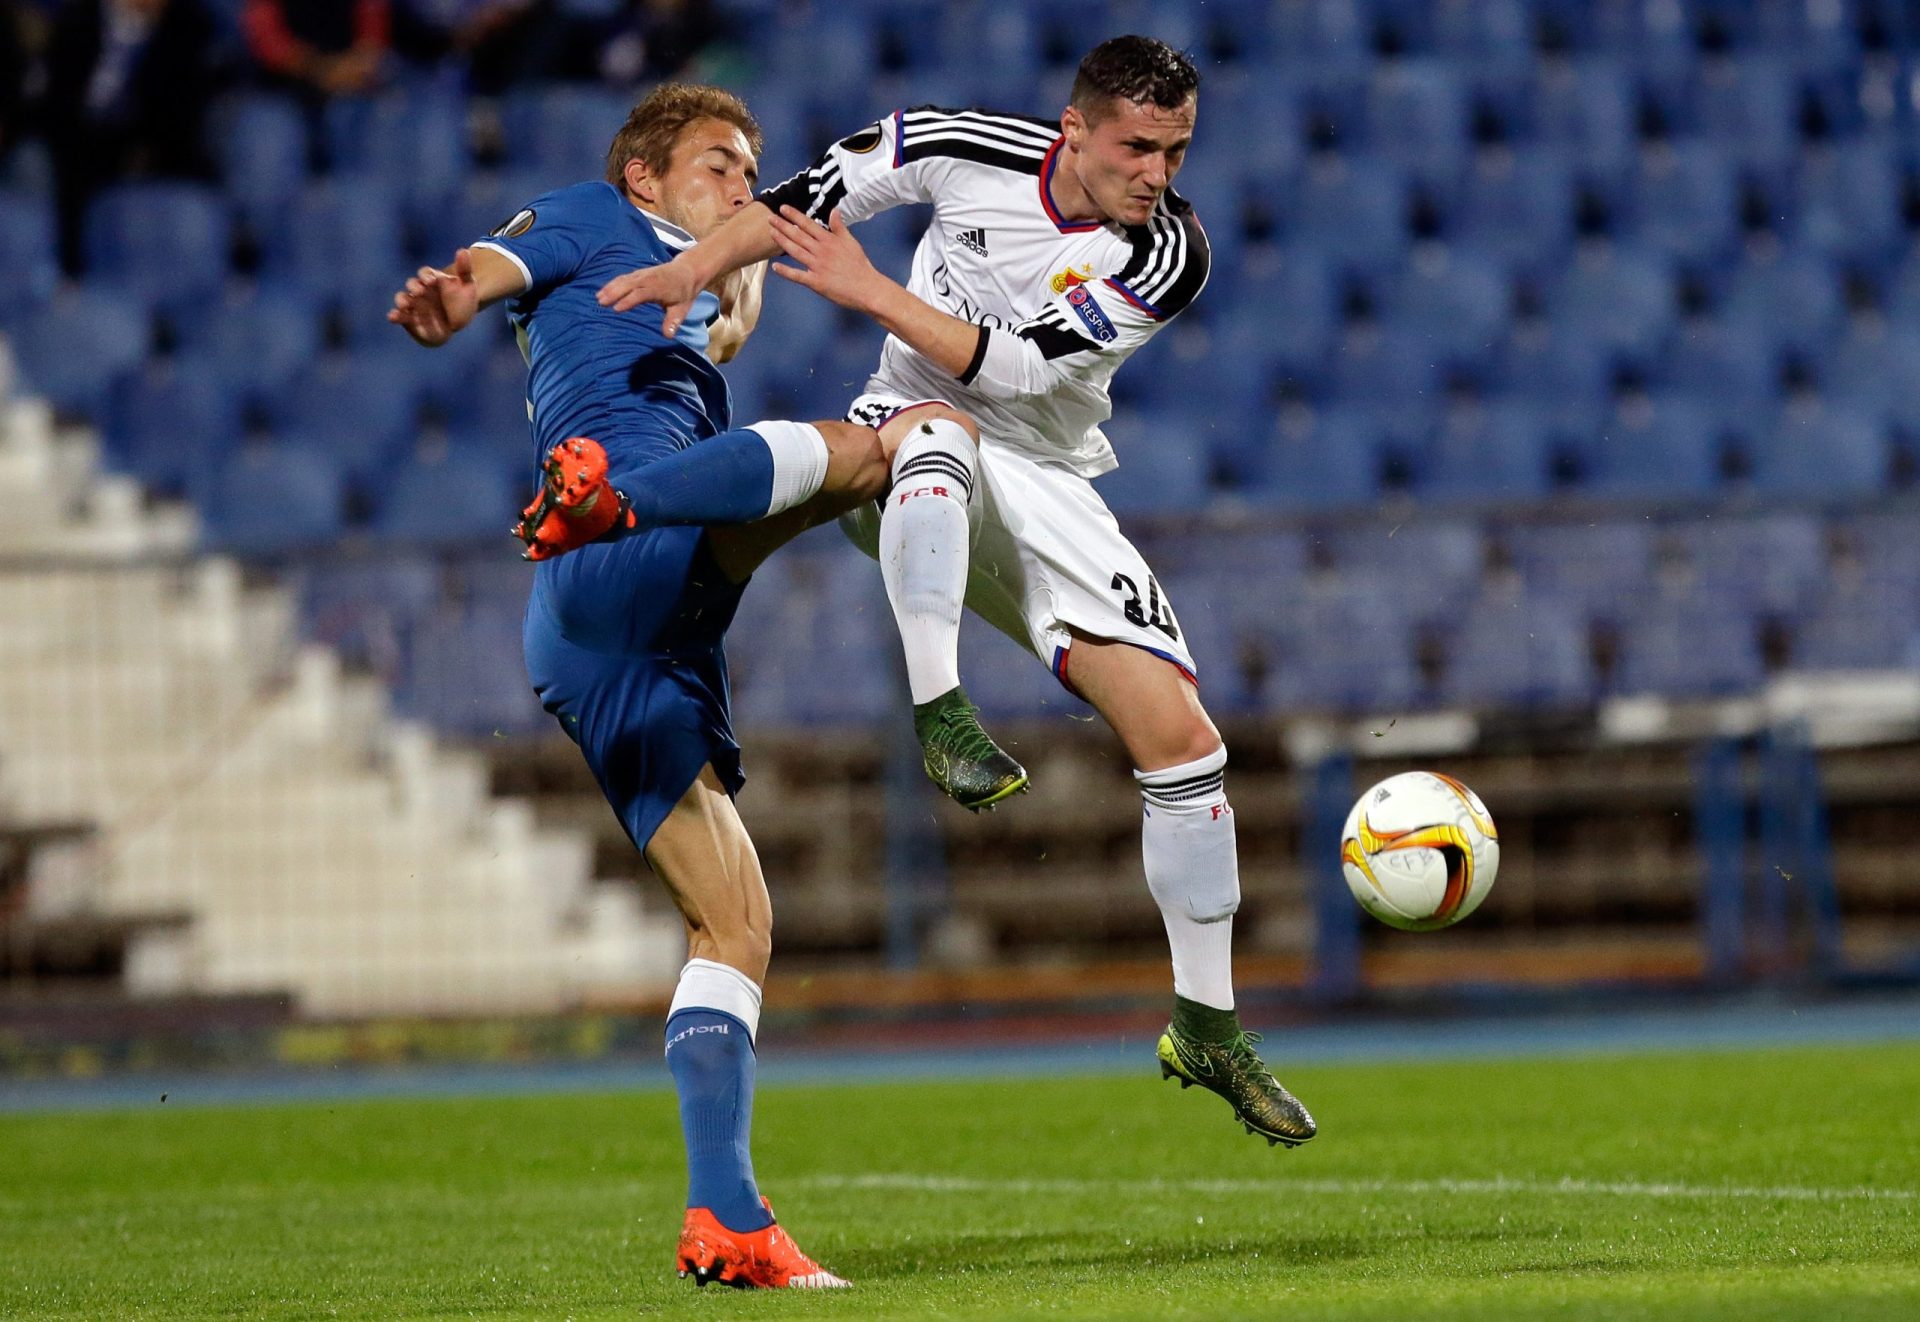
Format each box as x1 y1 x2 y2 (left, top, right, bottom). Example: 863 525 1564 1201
86 184 232 317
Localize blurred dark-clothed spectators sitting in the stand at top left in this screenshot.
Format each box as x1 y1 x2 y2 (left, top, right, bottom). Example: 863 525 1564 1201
0 0 720 276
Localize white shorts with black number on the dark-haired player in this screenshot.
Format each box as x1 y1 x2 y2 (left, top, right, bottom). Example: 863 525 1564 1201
841 395 1198 687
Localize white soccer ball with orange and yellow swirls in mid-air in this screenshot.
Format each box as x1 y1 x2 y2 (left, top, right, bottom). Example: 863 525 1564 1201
1340 771 1500 932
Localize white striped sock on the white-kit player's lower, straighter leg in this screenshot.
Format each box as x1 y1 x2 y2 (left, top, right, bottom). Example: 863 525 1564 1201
1133 748 1240 1009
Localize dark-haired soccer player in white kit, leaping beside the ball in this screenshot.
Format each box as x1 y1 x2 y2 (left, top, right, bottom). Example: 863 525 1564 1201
599 36 1315 1145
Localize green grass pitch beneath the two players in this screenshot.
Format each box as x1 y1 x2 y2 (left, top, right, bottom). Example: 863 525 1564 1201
0 1042 1920 1322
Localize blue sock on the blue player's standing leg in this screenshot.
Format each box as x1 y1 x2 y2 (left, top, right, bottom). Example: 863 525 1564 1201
666 1007 774 1232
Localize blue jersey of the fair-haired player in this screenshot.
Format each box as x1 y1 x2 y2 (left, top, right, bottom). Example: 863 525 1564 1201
474 182 732 482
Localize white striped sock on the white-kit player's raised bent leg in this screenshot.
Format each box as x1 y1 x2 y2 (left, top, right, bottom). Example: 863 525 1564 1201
879 418 975 704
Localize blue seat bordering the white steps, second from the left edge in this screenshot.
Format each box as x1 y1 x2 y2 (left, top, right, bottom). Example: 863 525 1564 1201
102 359 240 495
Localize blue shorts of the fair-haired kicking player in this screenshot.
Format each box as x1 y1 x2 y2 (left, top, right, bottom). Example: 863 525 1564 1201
522 528 745 850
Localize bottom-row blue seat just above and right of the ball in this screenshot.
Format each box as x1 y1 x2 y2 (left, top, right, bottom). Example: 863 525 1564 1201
1440 585 1596 706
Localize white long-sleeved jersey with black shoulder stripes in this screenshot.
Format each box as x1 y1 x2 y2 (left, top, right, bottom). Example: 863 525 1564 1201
760 106 1210 478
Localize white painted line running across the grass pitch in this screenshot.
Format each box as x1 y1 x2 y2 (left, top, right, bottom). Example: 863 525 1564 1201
795 1174 1920 1203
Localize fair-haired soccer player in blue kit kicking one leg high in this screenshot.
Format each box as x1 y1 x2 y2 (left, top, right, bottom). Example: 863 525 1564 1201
388 84 973 1287
